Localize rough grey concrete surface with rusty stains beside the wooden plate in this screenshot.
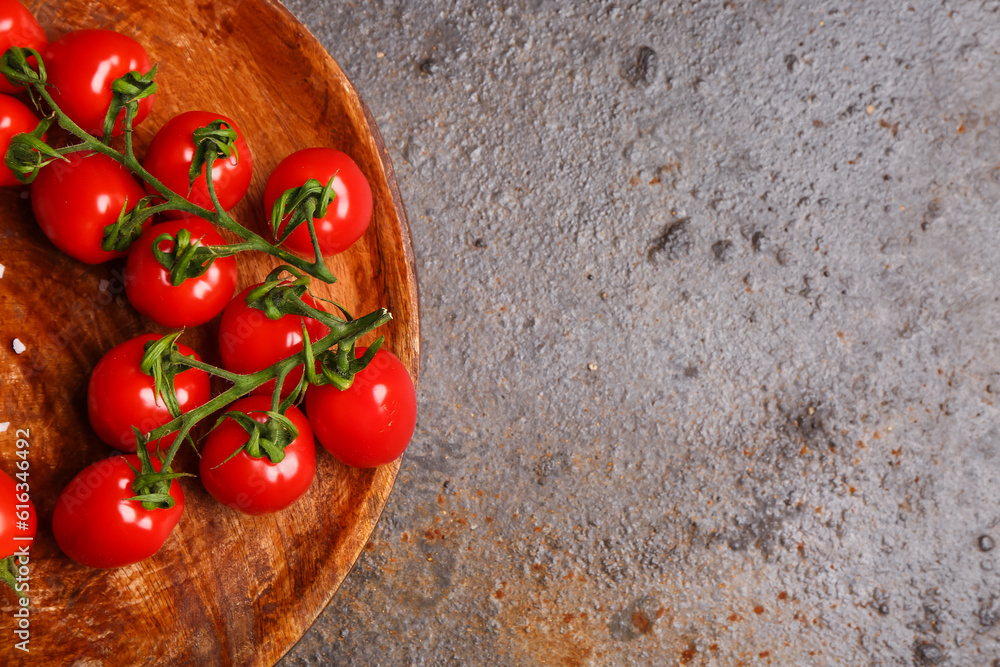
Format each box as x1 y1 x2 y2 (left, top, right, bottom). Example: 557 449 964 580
281 0 1000 667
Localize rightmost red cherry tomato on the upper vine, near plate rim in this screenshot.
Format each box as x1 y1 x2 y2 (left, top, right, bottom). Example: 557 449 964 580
264 148 372 256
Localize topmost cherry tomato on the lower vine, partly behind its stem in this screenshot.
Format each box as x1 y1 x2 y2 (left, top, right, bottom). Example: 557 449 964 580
219 283 330 396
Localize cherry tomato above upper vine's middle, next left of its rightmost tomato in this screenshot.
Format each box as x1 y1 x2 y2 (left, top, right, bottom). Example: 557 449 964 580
142 111 253 218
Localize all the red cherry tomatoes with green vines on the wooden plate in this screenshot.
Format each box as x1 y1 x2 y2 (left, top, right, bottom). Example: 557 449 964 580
0 0 416 575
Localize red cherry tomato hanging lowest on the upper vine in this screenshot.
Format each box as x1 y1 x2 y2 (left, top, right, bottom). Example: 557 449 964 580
124 218 236 328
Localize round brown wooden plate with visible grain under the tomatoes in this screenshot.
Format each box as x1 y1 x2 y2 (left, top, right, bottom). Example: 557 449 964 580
0 0 419 665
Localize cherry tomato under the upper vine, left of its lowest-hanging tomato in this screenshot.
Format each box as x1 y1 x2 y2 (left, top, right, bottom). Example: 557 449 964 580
31 152 149 264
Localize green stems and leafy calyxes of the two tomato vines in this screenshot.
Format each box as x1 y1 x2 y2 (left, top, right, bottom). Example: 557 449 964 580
0 46 391 528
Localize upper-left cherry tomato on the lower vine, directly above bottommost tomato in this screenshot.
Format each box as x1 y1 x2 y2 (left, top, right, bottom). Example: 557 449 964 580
87 334 211 453
